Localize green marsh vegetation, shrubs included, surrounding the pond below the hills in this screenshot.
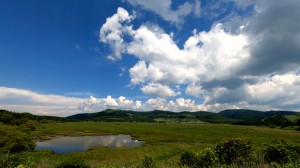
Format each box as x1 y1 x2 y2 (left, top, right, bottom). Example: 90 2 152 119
0 109 300 168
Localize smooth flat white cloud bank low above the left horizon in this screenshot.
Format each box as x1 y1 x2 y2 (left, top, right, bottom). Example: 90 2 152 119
0 87 82 116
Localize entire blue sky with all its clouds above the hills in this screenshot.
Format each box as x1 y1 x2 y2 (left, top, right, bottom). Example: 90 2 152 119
0 0 300 116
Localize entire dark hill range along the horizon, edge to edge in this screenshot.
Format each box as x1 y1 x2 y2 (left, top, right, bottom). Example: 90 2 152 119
0 109 300 125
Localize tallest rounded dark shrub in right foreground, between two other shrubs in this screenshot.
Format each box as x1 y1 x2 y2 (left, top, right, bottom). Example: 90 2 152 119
215 139 252 164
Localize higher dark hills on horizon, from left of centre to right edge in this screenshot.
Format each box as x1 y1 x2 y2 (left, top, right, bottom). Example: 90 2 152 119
66 109 300 125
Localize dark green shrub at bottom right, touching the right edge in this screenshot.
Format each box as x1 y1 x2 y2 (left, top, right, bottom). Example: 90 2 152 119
264 140 300 164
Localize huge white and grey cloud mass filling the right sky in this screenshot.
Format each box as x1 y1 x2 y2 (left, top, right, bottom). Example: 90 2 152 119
100 0 300 110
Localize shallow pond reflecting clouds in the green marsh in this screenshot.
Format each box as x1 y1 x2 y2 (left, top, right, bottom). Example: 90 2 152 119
35 135 144 154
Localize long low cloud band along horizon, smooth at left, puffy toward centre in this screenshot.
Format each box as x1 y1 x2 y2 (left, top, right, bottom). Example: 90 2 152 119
0 87 203 116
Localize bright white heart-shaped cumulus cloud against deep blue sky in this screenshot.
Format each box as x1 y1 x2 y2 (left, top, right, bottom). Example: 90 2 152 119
100 8 250 97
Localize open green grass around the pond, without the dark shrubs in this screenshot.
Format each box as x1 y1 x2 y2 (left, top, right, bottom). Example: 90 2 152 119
27 122 300 167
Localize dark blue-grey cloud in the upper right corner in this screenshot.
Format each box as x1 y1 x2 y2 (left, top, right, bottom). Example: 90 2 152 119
245 0 300 75
